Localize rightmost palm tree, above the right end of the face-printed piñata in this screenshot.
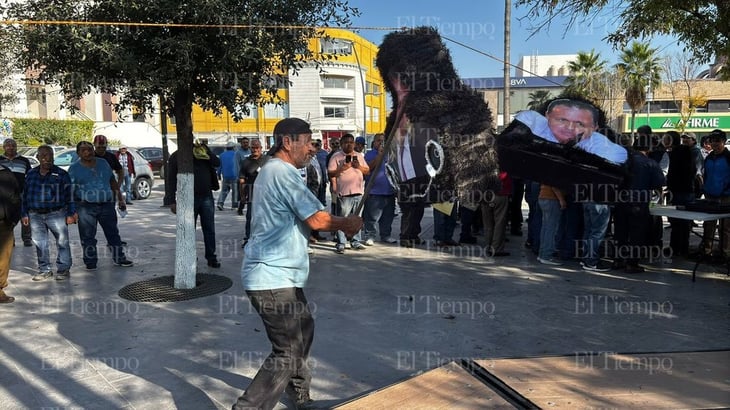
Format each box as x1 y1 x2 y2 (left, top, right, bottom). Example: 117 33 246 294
616 41 662 134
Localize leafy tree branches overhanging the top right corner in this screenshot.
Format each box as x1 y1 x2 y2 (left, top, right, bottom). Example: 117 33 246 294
515 0 730 78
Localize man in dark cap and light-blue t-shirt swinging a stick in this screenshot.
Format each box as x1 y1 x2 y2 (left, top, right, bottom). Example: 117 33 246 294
233 118 362 410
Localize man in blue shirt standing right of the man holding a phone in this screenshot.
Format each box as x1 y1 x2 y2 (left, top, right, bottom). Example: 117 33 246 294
362 134 398 246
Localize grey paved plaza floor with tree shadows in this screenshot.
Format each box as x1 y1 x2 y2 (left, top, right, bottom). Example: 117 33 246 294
0 183 730 410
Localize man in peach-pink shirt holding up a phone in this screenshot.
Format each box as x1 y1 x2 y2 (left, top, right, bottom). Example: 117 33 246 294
327 134 370 254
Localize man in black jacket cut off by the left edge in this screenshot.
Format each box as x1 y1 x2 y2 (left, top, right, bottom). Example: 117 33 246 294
0 165 21 303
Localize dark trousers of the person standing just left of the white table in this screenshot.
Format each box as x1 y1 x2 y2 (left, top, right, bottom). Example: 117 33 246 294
614 203 661 266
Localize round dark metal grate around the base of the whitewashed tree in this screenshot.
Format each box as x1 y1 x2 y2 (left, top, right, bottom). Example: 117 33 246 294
119 273 233 302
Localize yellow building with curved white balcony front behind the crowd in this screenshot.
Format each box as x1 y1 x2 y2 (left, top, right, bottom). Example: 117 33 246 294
168 28 386 147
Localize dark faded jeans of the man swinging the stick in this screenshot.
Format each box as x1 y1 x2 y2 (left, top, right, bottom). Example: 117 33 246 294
233 288 314 410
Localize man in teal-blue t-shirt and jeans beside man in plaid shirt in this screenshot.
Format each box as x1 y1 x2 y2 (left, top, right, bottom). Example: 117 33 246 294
68 141 134 270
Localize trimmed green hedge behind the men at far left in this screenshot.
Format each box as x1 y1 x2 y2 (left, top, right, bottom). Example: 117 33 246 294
12 118 94 147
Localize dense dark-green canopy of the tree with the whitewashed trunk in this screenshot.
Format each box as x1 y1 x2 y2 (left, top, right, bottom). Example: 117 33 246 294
8 0 357 119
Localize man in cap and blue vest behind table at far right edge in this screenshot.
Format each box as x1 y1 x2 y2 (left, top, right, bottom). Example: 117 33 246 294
700 129 730 258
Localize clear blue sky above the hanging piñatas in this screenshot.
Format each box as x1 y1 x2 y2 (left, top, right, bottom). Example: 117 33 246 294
349 0 680 78
